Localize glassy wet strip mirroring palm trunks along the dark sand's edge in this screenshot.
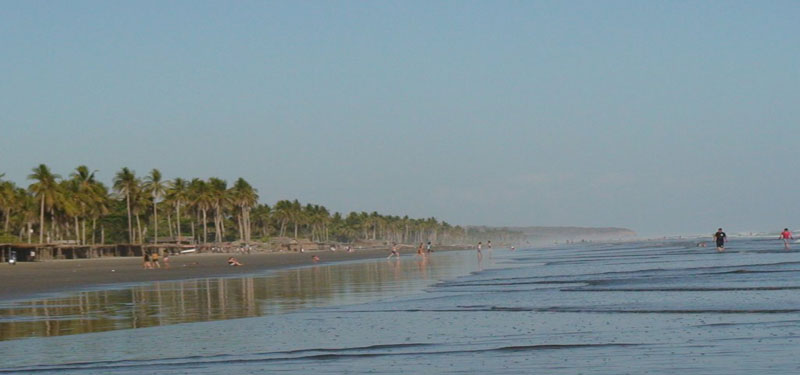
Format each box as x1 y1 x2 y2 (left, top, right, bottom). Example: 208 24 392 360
0 253 470 340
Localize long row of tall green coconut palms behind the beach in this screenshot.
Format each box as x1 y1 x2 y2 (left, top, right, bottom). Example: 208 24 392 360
0 164 524 245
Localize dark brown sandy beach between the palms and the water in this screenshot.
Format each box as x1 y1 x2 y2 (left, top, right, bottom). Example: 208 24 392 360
0 246 469 302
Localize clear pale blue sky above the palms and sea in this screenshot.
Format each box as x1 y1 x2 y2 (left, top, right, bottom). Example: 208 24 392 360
0 0 800 235
